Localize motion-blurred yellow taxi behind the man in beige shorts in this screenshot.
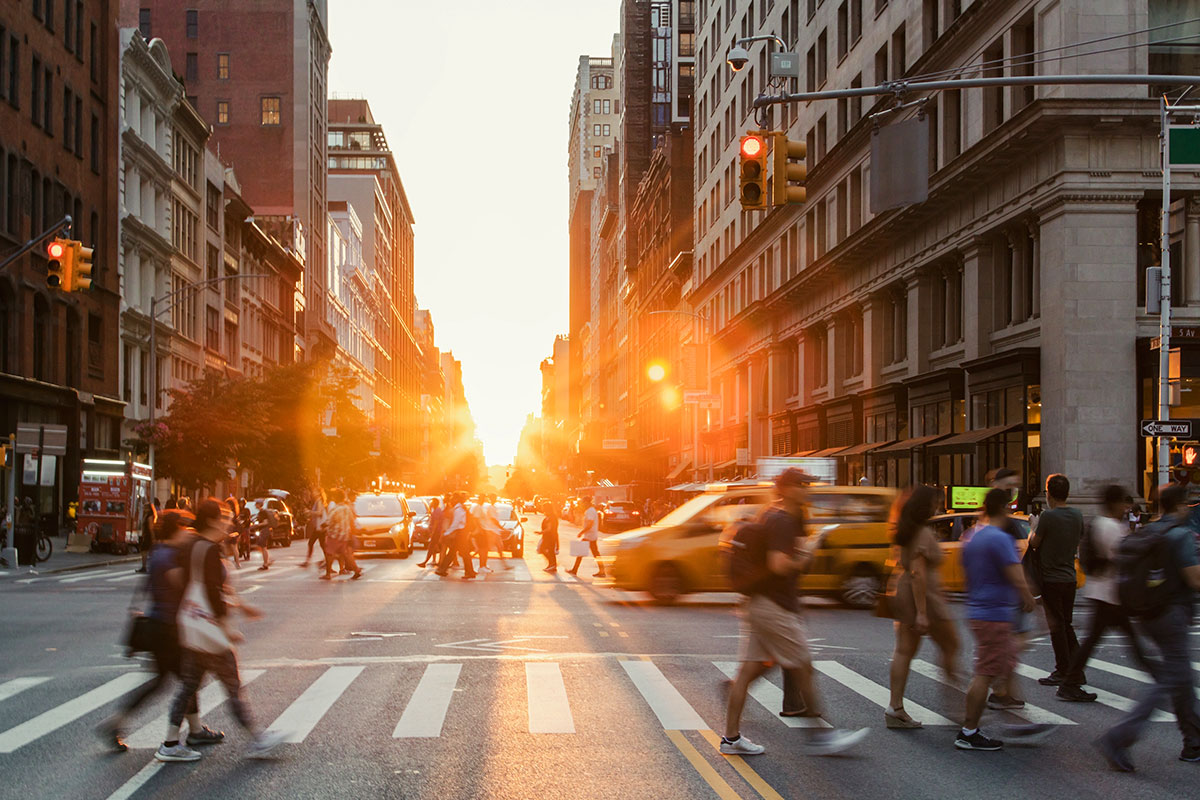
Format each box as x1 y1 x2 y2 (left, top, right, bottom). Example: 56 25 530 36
600 482 896 608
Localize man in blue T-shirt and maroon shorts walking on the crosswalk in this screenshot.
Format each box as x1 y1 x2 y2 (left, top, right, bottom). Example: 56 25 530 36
954 489 1050 751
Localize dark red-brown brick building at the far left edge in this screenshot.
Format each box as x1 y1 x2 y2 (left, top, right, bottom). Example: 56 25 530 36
0 0 124 517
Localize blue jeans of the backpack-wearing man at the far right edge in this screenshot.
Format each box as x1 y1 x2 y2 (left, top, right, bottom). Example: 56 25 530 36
1105 606 1200 748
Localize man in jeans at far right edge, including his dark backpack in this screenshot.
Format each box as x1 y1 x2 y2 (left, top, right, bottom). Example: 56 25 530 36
1096 485 1200 772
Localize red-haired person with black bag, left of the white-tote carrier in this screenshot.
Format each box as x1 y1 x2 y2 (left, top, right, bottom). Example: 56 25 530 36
100 510 224 753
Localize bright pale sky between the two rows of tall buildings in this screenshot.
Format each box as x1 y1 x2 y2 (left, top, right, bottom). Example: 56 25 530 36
329 0 620 464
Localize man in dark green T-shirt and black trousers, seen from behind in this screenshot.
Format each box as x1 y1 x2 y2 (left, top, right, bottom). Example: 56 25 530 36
1030 473 1096 702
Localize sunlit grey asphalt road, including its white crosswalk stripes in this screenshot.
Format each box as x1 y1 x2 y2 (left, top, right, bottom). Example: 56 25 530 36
0 517 1200 800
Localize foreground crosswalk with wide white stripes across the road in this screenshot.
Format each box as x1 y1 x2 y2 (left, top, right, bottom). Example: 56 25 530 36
0 656 1174 763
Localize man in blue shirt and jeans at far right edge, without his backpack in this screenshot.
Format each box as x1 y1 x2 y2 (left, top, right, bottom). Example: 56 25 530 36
1096 483 1200 772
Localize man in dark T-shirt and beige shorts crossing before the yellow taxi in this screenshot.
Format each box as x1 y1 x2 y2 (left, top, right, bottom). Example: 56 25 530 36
720 468 868 756
